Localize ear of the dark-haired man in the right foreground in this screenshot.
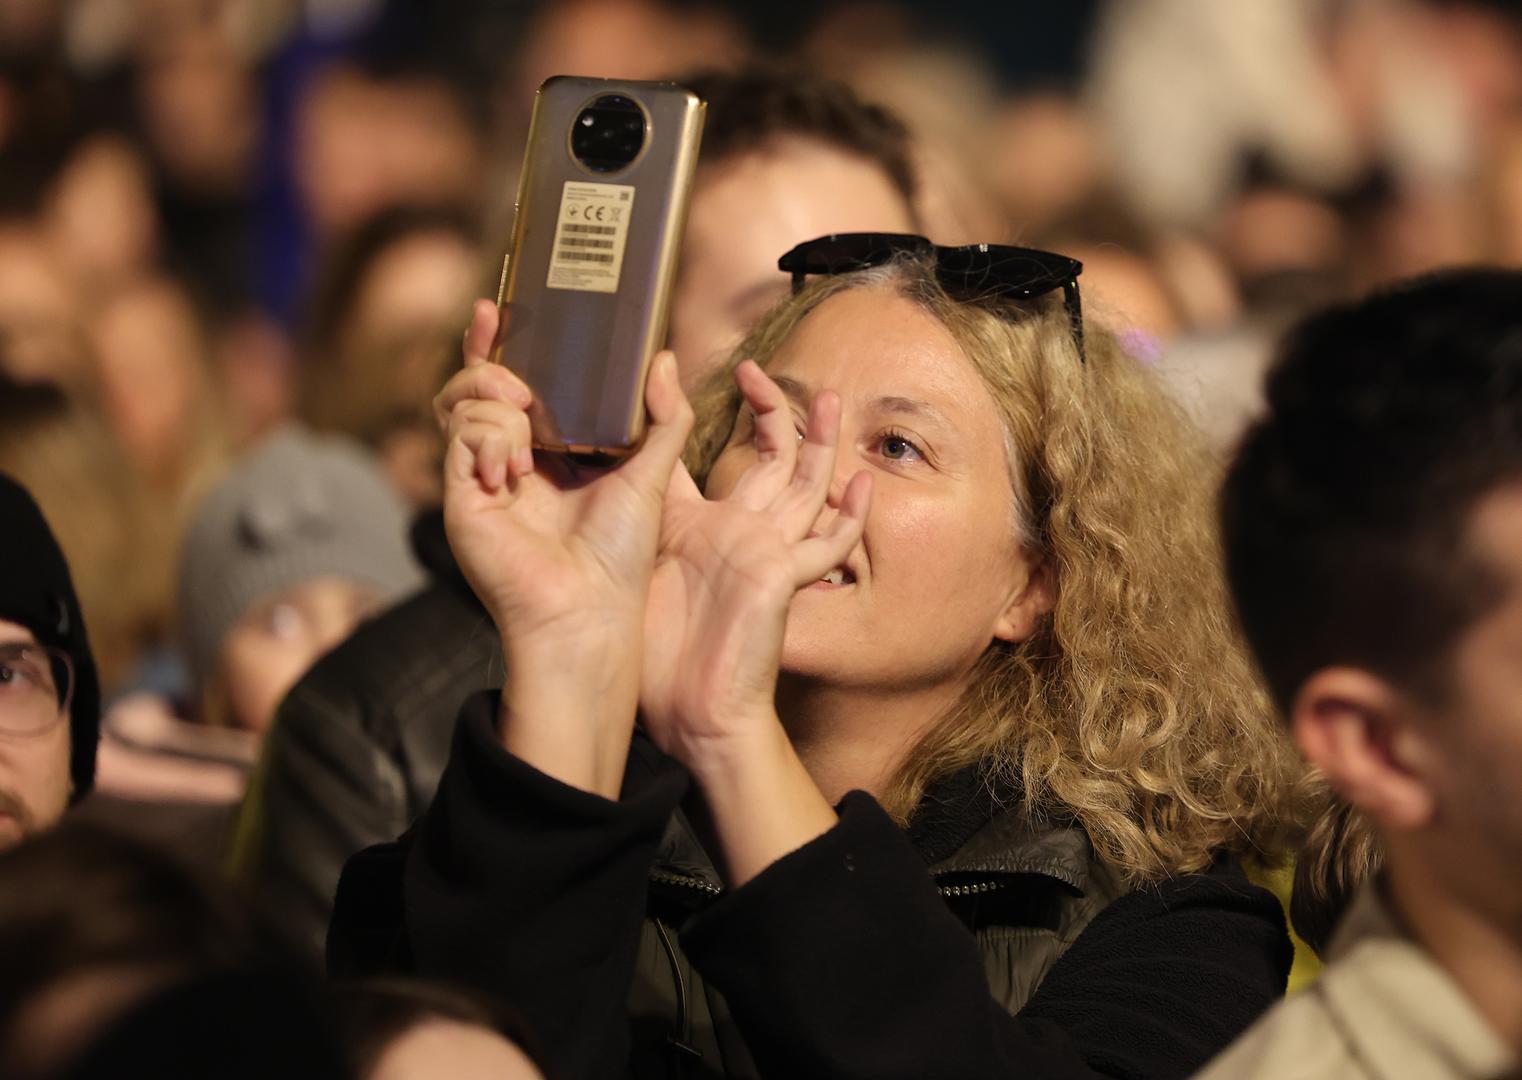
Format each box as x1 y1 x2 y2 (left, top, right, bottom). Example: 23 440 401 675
1289 668 1437 832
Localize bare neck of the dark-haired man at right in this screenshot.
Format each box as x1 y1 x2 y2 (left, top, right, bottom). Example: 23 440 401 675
1383 852 1522 1053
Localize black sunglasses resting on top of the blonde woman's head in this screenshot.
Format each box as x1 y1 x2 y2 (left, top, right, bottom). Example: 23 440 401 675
776 233 1084 361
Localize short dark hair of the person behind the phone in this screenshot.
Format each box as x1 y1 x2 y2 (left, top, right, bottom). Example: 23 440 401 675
677 64 916 202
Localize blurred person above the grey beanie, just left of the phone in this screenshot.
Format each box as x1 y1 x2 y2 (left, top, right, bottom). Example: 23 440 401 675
298 207 482 510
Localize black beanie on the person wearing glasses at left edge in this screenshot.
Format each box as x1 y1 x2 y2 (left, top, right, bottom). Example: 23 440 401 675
0 473 100 802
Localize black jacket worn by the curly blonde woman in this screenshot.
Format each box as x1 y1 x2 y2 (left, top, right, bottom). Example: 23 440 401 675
329 695 1291 1080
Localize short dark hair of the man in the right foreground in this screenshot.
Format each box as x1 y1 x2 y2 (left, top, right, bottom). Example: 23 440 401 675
1221 269 1522 712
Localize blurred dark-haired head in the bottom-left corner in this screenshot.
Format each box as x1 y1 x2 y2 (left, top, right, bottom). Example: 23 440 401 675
0 823 349 1080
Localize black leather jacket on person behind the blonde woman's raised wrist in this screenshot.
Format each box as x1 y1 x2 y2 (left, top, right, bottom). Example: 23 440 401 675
231 511 502 960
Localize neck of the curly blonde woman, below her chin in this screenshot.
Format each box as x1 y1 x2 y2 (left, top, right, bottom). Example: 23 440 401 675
776 674 957 805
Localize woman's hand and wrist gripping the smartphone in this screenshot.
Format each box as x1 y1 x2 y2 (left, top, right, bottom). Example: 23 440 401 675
434 300 693 796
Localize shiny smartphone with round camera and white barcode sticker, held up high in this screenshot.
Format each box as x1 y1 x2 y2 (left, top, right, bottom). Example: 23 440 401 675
493 76 706 458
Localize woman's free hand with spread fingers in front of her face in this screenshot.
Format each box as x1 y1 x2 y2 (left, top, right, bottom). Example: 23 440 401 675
639 362 872 882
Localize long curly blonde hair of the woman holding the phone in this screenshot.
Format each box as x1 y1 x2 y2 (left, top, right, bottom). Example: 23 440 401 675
688 259 1304 884
